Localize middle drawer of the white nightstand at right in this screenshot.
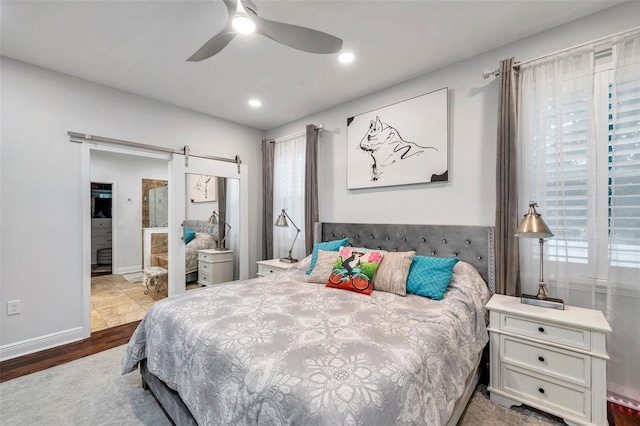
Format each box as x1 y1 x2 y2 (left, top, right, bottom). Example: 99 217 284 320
501 336 591 387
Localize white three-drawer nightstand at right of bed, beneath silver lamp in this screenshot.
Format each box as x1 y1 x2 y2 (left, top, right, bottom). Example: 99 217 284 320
487 294 611 425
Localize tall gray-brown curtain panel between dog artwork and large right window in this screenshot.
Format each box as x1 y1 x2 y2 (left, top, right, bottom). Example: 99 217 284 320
495 58 525 296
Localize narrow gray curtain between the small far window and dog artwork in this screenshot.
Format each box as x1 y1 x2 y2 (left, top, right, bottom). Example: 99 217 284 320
304 124 318 255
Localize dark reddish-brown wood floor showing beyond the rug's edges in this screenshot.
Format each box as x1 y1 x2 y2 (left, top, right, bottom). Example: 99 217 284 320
0 321 640 426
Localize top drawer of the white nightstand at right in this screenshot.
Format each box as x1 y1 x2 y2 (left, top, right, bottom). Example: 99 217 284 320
500 314 591 350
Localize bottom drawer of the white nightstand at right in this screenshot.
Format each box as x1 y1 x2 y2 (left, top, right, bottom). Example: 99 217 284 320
501 364 591 421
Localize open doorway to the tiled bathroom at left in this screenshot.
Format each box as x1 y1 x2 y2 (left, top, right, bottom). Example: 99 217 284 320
86 147 169 332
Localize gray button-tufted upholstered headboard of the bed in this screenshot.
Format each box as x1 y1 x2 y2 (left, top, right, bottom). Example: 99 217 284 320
314 222 495 292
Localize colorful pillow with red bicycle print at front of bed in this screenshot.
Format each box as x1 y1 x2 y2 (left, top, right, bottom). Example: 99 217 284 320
327 247 383 294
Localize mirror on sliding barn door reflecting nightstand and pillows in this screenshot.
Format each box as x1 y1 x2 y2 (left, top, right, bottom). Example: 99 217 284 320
184 174 240 289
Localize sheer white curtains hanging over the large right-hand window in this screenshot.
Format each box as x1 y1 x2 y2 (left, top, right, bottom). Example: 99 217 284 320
518 30 640 406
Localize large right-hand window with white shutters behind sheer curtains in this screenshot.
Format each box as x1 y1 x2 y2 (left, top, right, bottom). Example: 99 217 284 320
519 44 640 296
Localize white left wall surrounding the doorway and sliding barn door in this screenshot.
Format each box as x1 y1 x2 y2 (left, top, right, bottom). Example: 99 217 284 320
0 57 263 357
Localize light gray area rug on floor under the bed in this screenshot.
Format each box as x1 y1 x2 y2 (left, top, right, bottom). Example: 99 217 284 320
0 345 561 426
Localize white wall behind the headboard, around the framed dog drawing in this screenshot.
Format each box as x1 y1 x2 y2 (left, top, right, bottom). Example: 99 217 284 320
267 2 640 230
